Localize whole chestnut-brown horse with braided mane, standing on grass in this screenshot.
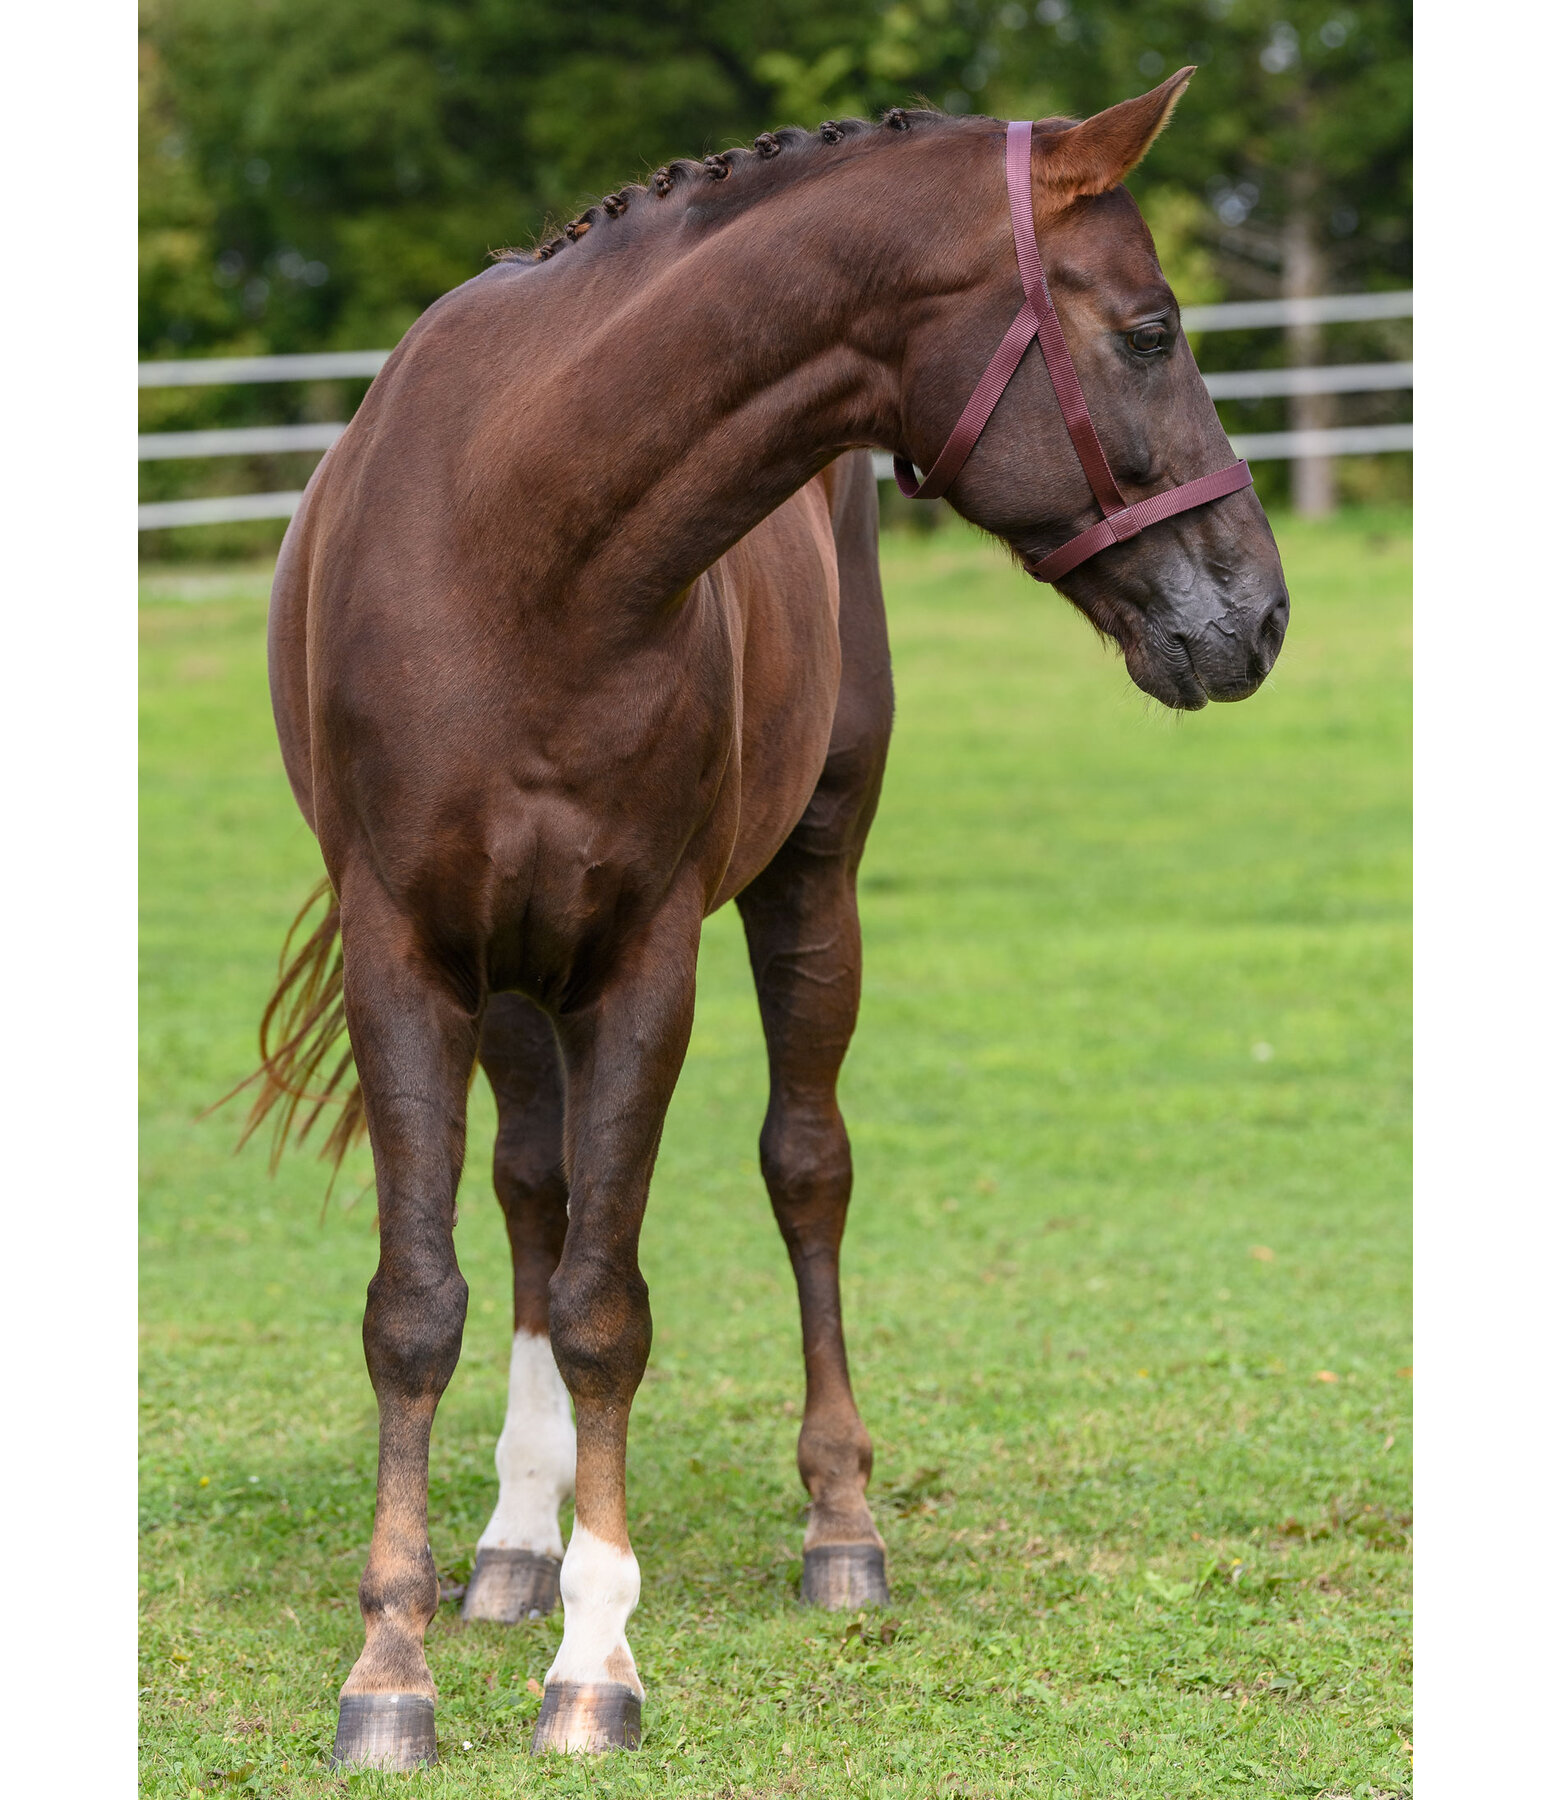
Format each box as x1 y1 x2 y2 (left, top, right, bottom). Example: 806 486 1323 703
254 68 1287 1769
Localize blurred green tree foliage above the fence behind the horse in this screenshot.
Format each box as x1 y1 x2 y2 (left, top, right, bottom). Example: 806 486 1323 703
142 0 1410 356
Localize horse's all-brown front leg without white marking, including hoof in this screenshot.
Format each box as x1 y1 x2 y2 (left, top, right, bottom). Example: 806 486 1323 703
325 882 479 1769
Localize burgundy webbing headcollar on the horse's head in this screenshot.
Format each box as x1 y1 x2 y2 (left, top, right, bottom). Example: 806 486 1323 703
893 119 1255 581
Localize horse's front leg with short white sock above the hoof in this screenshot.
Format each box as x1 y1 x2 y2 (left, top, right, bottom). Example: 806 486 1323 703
533 893 700 1750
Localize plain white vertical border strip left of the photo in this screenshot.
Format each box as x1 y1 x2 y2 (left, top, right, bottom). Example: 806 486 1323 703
0 0 137 1771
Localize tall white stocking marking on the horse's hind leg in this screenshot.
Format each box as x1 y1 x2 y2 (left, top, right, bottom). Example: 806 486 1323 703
479 1332 576 1559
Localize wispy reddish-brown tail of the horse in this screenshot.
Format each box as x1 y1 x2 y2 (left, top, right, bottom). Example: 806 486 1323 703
236 878 365 1174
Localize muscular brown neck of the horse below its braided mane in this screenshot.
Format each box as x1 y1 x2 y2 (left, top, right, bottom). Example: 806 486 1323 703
478 144 996 605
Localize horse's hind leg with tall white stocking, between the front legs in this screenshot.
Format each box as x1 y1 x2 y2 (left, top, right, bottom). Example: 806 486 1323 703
463 994 576 1625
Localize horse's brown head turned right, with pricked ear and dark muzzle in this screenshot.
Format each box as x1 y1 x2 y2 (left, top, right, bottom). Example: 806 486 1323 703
900 70 1287 709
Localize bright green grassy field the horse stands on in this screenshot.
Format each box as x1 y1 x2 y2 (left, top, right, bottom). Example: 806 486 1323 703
140 511 1411 1800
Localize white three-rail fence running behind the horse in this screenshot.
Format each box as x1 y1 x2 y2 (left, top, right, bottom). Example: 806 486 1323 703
139 290 1415 531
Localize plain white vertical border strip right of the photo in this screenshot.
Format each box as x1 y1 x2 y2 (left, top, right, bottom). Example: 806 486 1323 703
1415 0 1550 1800
